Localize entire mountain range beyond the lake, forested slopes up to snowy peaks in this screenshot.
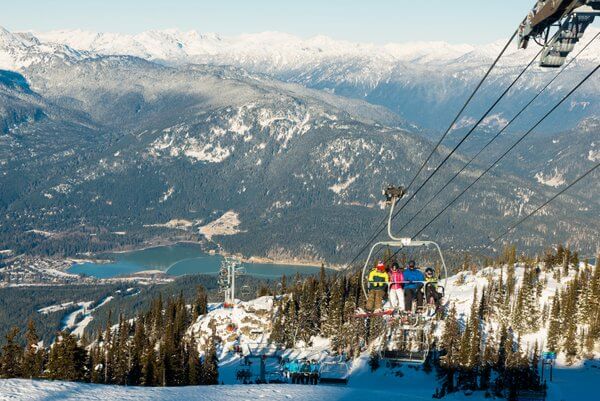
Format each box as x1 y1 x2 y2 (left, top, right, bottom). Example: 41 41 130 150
0 29 600 263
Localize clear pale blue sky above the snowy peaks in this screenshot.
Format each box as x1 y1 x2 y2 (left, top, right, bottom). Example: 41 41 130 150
0 0 534 44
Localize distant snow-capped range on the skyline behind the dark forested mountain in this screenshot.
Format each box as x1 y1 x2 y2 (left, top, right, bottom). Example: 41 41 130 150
11 28 600 136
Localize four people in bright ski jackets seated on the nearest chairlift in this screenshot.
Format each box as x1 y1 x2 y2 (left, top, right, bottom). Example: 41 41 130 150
367 260 441 312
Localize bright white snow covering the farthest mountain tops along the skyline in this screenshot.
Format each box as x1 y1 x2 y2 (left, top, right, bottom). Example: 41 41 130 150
29 27 598 70
